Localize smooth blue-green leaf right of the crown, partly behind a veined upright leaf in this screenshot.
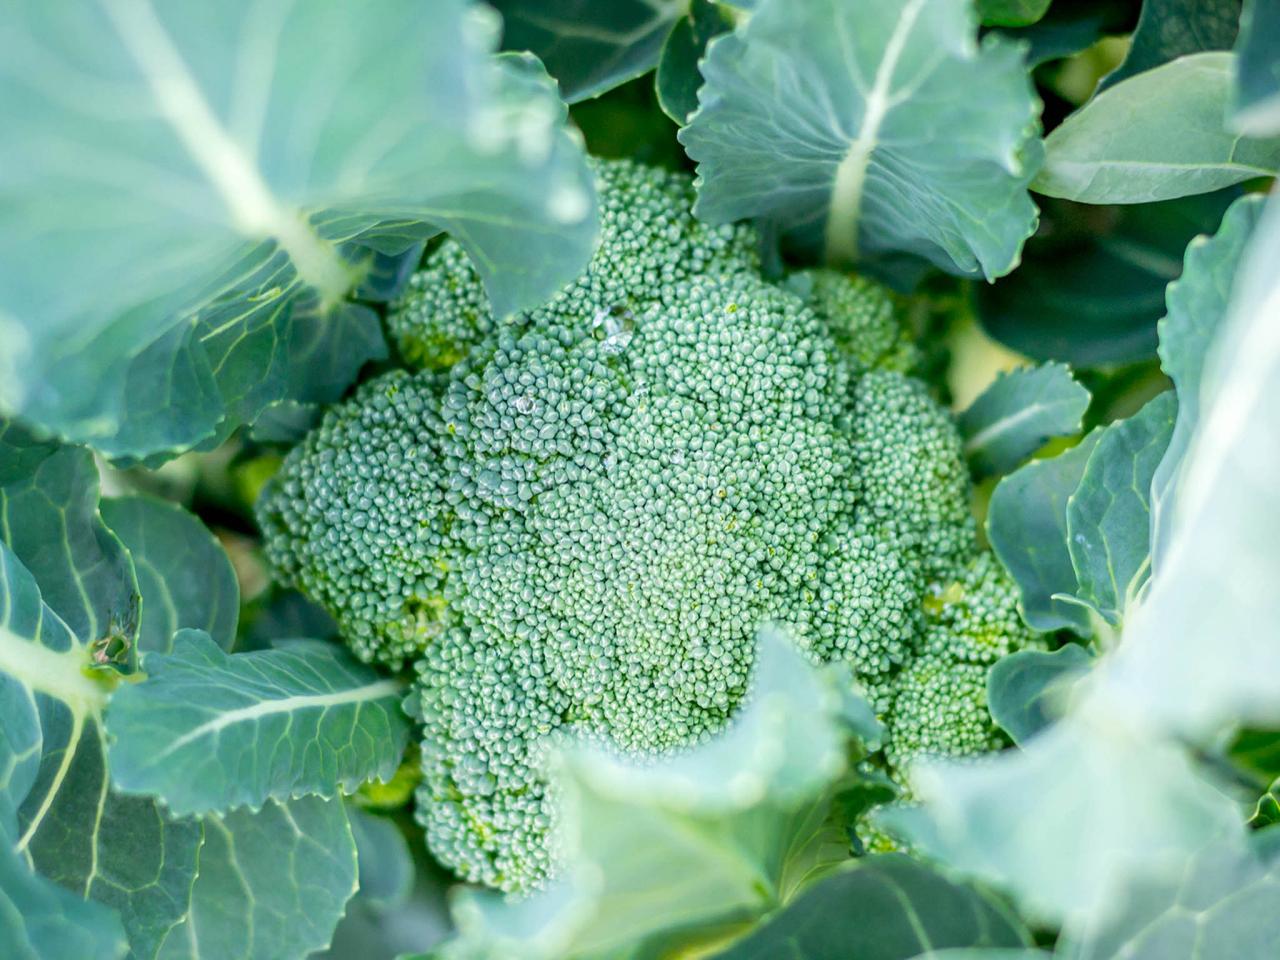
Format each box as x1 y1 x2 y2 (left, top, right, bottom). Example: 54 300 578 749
987 431 1098 636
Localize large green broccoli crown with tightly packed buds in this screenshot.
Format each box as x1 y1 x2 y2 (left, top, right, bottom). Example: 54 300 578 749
259 161 1021 891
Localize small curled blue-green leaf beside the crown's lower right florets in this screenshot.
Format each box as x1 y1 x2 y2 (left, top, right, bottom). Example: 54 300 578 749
987 644 1093 746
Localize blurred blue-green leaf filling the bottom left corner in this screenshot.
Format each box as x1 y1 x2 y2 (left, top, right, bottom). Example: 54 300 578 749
0 827 129 960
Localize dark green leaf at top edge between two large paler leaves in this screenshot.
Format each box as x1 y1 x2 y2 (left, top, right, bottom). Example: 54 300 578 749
493 0 690 104
